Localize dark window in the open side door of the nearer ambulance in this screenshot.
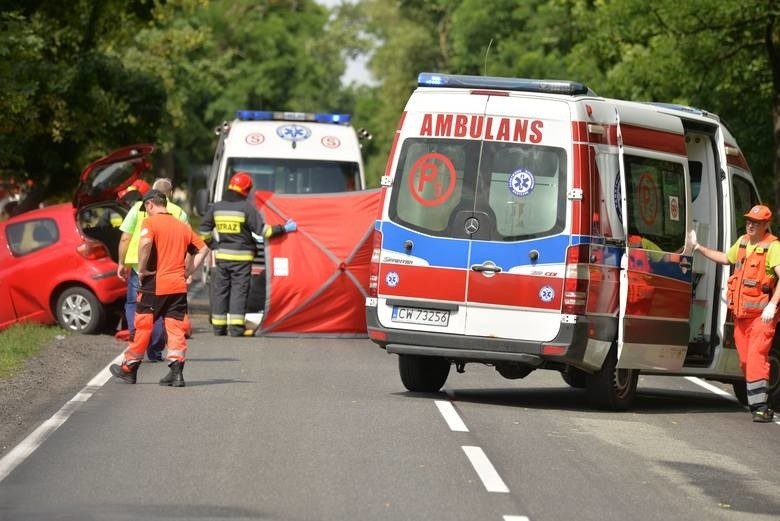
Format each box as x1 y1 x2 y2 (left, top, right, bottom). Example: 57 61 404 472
624 155 686 251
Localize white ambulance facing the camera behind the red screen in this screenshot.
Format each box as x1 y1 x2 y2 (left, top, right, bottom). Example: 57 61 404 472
196 110 371 313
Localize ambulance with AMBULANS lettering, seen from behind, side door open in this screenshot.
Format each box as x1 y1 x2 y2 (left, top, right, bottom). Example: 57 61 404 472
366 73 780 410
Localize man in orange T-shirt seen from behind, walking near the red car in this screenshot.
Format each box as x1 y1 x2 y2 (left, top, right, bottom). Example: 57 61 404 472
110 190 209 387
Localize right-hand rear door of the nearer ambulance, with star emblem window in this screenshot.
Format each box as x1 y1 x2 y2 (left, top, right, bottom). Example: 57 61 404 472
454 94 571 345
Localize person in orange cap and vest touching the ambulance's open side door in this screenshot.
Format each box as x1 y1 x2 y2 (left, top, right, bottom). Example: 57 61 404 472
688 205 780 423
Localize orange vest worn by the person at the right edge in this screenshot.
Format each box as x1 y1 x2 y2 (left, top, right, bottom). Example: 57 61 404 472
727 233 777 318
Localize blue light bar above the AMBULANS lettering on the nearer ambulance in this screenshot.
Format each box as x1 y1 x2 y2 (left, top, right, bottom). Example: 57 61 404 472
417 72 595 96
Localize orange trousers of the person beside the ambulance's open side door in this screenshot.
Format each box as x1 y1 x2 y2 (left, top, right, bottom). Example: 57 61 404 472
734 315 778 382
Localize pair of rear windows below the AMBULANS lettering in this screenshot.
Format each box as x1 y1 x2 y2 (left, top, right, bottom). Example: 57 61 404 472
390 139 566 241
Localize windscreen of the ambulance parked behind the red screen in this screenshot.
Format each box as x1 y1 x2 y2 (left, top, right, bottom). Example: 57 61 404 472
225 158 360 194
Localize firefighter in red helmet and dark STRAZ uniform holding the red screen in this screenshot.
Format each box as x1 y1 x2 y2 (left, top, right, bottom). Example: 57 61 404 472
198 172 297 336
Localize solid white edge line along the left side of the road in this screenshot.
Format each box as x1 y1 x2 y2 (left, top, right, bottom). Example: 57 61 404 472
0 353 123 481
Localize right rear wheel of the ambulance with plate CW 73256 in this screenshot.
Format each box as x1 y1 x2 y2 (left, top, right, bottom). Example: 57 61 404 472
588 346 639 411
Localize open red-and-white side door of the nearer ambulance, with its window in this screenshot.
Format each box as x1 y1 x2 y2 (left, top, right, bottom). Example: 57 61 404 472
616 105 692 372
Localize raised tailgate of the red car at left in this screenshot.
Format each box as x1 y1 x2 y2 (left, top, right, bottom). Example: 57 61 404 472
73 143 155 208
